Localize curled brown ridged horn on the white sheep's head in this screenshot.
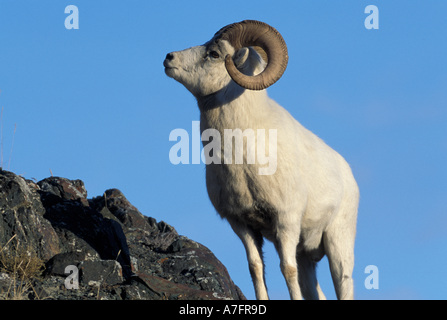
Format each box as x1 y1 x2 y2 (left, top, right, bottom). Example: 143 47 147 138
216 20 289 90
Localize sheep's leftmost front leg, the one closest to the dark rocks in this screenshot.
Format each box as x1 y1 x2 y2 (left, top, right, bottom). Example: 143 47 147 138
228 219 269 300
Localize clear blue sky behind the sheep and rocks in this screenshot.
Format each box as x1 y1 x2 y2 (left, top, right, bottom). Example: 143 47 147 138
0 0 447 299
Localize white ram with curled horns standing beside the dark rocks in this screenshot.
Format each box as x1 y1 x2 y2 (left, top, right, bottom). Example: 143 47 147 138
164 20 359 299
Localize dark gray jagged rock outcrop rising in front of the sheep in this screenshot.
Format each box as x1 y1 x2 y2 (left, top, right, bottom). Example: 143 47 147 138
0 170 245 300
